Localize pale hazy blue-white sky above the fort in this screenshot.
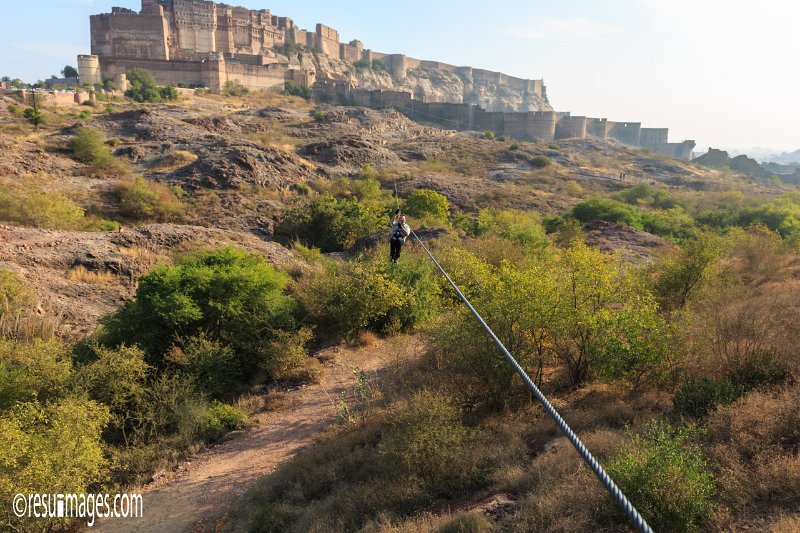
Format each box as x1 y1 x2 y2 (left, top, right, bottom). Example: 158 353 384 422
0 0 800 150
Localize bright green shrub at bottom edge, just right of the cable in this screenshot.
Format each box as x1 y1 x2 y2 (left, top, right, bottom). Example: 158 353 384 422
607 422 715 531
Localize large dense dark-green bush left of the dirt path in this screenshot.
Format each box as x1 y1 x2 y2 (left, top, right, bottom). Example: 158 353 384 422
103 248 292 380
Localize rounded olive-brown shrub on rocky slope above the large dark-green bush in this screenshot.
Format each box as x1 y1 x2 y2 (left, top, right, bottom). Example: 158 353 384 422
112 176 185 222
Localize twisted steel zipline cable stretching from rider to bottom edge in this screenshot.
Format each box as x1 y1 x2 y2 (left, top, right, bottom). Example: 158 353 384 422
411 230 653 533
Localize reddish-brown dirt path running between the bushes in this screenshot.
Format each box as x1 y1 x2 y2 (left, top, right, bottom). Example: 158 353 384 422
92 341 416 533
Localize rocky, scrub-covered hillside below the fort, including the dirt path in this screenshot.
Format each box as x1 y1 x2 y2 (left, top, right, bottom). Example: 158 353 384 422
0 88 800 532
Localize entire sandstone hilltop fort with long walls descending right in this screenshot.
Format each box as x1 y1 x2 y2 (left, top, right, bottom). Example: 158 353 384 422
78 0 694 159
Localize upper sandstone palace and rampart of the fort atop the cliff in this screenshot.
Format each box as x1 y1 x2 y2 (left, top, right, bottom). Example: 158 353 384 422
90 0 546 101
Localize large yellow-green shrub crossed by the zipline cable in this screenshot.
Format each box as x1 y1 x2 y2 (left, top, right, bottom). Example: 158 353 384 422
433 243 669 392
